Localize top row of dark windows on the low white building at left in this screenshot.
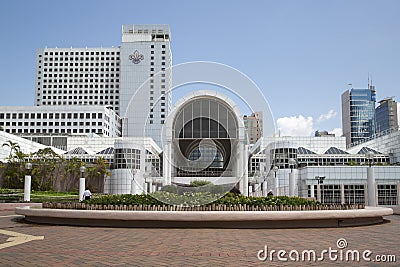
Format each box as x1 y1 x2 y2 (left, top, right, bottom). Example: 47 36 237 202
0 113 103 120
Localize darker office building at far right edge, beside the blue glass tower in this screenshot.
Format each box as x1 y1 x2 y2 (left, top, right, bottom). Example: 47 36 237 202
375 97 399 133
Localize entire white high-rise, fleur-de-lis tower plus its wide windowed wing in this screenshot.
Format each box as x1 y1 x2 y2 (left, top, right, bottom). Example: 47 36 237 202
34 25 172 147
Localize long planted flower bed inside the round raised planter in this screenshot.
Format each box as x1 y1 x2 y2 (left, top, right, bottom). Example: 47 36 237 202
43 192 364 211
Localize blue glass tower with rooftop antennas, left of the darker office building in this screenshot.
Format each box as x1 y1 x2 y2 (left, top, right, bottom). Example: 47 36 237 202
342 85 376 145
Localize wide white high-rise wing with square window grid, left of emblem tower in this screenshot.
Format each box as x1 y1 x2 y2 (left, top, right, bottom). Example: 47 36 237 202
34 47 121 114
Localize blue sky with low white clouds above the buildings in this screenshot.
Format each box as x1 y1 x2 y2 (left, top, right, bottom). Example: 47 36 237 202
0 0 400 136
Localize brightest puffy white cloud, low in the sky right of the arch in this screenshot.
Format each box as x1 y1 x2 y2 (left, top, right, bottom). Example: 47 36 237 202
276 115 314 136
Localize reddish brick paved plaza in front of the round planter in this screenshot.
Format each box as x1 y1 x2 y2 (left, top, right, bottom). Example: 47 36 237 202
0 205 400 266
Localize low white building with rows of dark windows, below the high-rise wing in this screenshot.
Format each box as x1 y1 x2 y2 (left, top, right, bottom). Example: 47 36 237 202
0 105 122 145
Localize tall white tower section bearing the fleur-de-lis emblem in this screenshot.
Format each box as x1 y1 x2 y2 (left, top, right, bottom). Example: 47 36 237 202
120 25 172 145
